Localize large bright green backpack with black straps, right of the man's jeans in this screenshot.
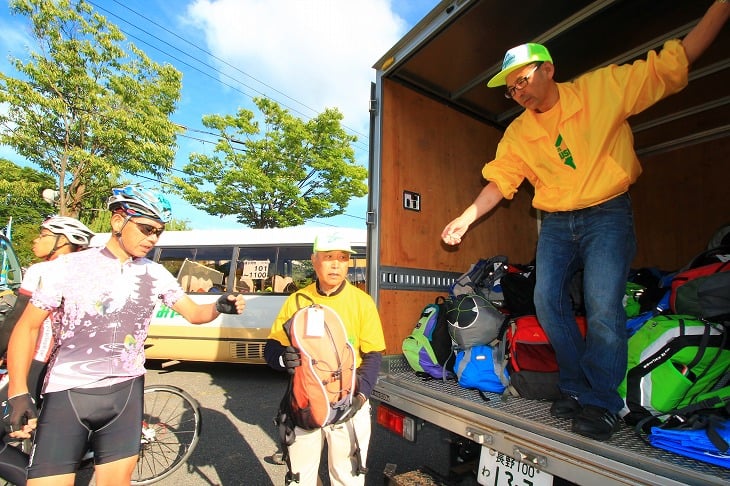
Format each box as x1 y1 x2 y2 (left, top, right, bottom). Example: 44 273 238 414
618 315 730 425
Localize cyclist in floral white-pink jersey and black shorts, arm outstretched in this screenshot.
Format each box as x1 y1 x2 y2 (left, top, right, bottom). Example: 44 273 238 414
3 186 246 486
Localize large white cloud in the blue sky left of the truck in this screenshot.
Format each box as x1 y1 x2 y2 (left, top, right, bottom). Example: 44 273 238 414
186 0 406 138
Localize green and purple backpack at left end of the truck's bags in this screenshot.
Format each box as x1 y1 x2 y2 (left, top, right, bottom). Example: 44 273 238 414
401 297 455 380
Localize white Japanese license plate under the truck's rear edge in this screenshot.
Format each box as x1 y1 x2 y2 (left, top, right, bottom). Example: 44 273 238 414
477 447 553 486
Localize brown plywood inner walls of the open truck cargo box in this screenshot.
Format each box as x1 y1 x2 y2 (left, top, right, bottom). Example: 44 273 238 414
372 79 730 354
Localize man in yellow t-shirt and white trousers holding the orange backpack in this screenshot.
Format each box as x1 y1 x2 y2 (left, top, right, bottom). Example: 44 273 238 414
264 231 385 486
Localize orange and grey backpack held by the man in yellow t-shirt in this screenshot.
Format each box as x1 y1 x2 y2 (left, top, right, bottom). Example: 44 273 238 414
282 304 356 429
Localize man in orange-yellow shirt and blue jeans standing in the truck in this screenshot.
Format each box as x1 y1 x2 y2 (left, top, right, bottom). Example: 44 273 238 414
441 0 730 440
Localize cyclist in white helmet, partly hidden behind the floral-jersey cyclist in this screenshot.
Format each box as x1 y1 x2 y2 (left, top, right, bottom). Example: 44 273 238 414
0 216 94 485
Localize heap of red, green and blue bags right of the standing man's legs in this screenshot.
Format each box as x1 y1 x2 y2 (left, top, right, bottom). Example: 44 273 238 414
619 245 730 467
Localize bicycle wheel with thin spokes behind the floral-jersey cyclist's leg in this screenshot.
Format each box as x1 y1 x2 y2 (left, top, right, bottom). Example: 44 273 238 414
132 385 202 485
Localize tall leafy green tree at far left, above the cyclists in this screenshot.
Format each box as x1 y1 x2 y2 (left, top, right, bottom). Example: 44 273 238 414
0 0 182 216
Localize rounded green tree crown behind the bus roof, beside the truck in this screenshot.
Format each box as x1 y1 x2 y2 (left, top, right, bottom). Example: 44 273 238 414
173 98 367 228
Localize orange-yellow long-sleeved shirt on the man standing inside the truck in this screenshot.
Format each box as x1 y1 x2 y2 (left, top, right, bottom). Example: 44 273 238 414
482 40 689 212
